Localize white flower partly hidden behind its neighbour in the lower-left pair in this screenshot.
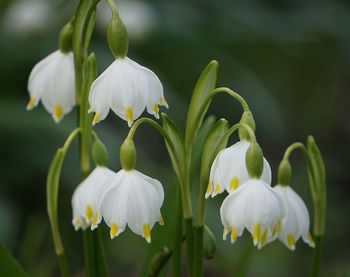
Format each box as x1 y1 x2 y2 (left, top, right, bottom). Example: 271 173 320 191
72 166 116 230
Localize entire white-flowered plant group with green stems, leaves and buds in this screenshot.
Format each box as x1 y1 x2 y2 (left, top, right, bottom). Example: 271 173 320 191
23 0 326 277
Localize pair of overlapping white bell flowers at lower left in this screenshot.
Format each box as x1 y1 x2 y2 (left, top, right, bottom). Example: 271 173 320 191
72 166 164 242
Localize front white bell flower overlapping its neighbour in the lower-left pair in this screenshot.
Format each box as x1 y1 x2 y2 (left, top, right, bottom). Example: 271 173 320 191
101 169 164 242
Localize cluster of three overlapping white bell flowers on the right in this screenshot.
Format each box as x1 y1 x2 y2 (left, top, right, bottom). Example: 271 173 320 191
206 140 314 250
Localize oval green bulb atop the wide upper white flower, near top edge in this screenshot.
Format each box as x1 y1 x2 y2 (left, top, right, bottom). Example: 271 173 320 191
107 15 129 58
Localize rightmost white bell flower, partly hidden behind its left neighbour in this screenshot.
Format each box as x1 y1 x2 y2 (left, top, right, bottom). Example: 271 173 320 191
274 185 315 250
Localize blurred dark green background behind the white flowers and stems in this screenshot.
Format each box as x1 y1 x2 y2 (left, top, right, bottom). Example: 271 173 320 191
0 0 350 276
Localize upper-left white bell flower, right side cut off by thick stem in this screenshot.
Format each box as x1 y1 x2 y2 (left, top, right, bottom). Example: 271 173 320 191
27 50 75 123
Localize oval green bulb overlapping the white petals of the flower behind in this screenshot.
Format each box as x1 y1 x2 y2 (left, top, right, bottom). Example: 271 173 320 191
245 142 264 179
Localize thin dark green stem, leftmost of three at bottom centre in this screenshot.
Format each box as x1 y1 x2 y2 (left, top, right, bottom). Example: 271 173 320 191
173 187 183 277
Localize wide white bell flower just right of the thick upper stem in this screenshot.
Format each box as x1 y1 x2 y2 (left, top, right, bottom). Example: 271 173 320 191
89 57 167 127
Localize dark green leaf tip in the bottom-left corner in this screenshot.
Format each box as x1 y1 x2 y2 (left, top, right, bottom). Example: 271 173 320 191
0 243 29 277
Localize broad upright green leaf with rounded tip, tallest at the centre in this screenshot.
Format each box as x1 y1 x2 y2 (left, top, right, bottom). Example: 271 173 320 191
185 61 218 150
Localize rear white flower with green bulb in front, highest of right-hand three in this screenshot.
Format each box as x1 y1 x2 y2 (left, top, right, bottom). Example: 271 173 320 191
205 140 271 198
